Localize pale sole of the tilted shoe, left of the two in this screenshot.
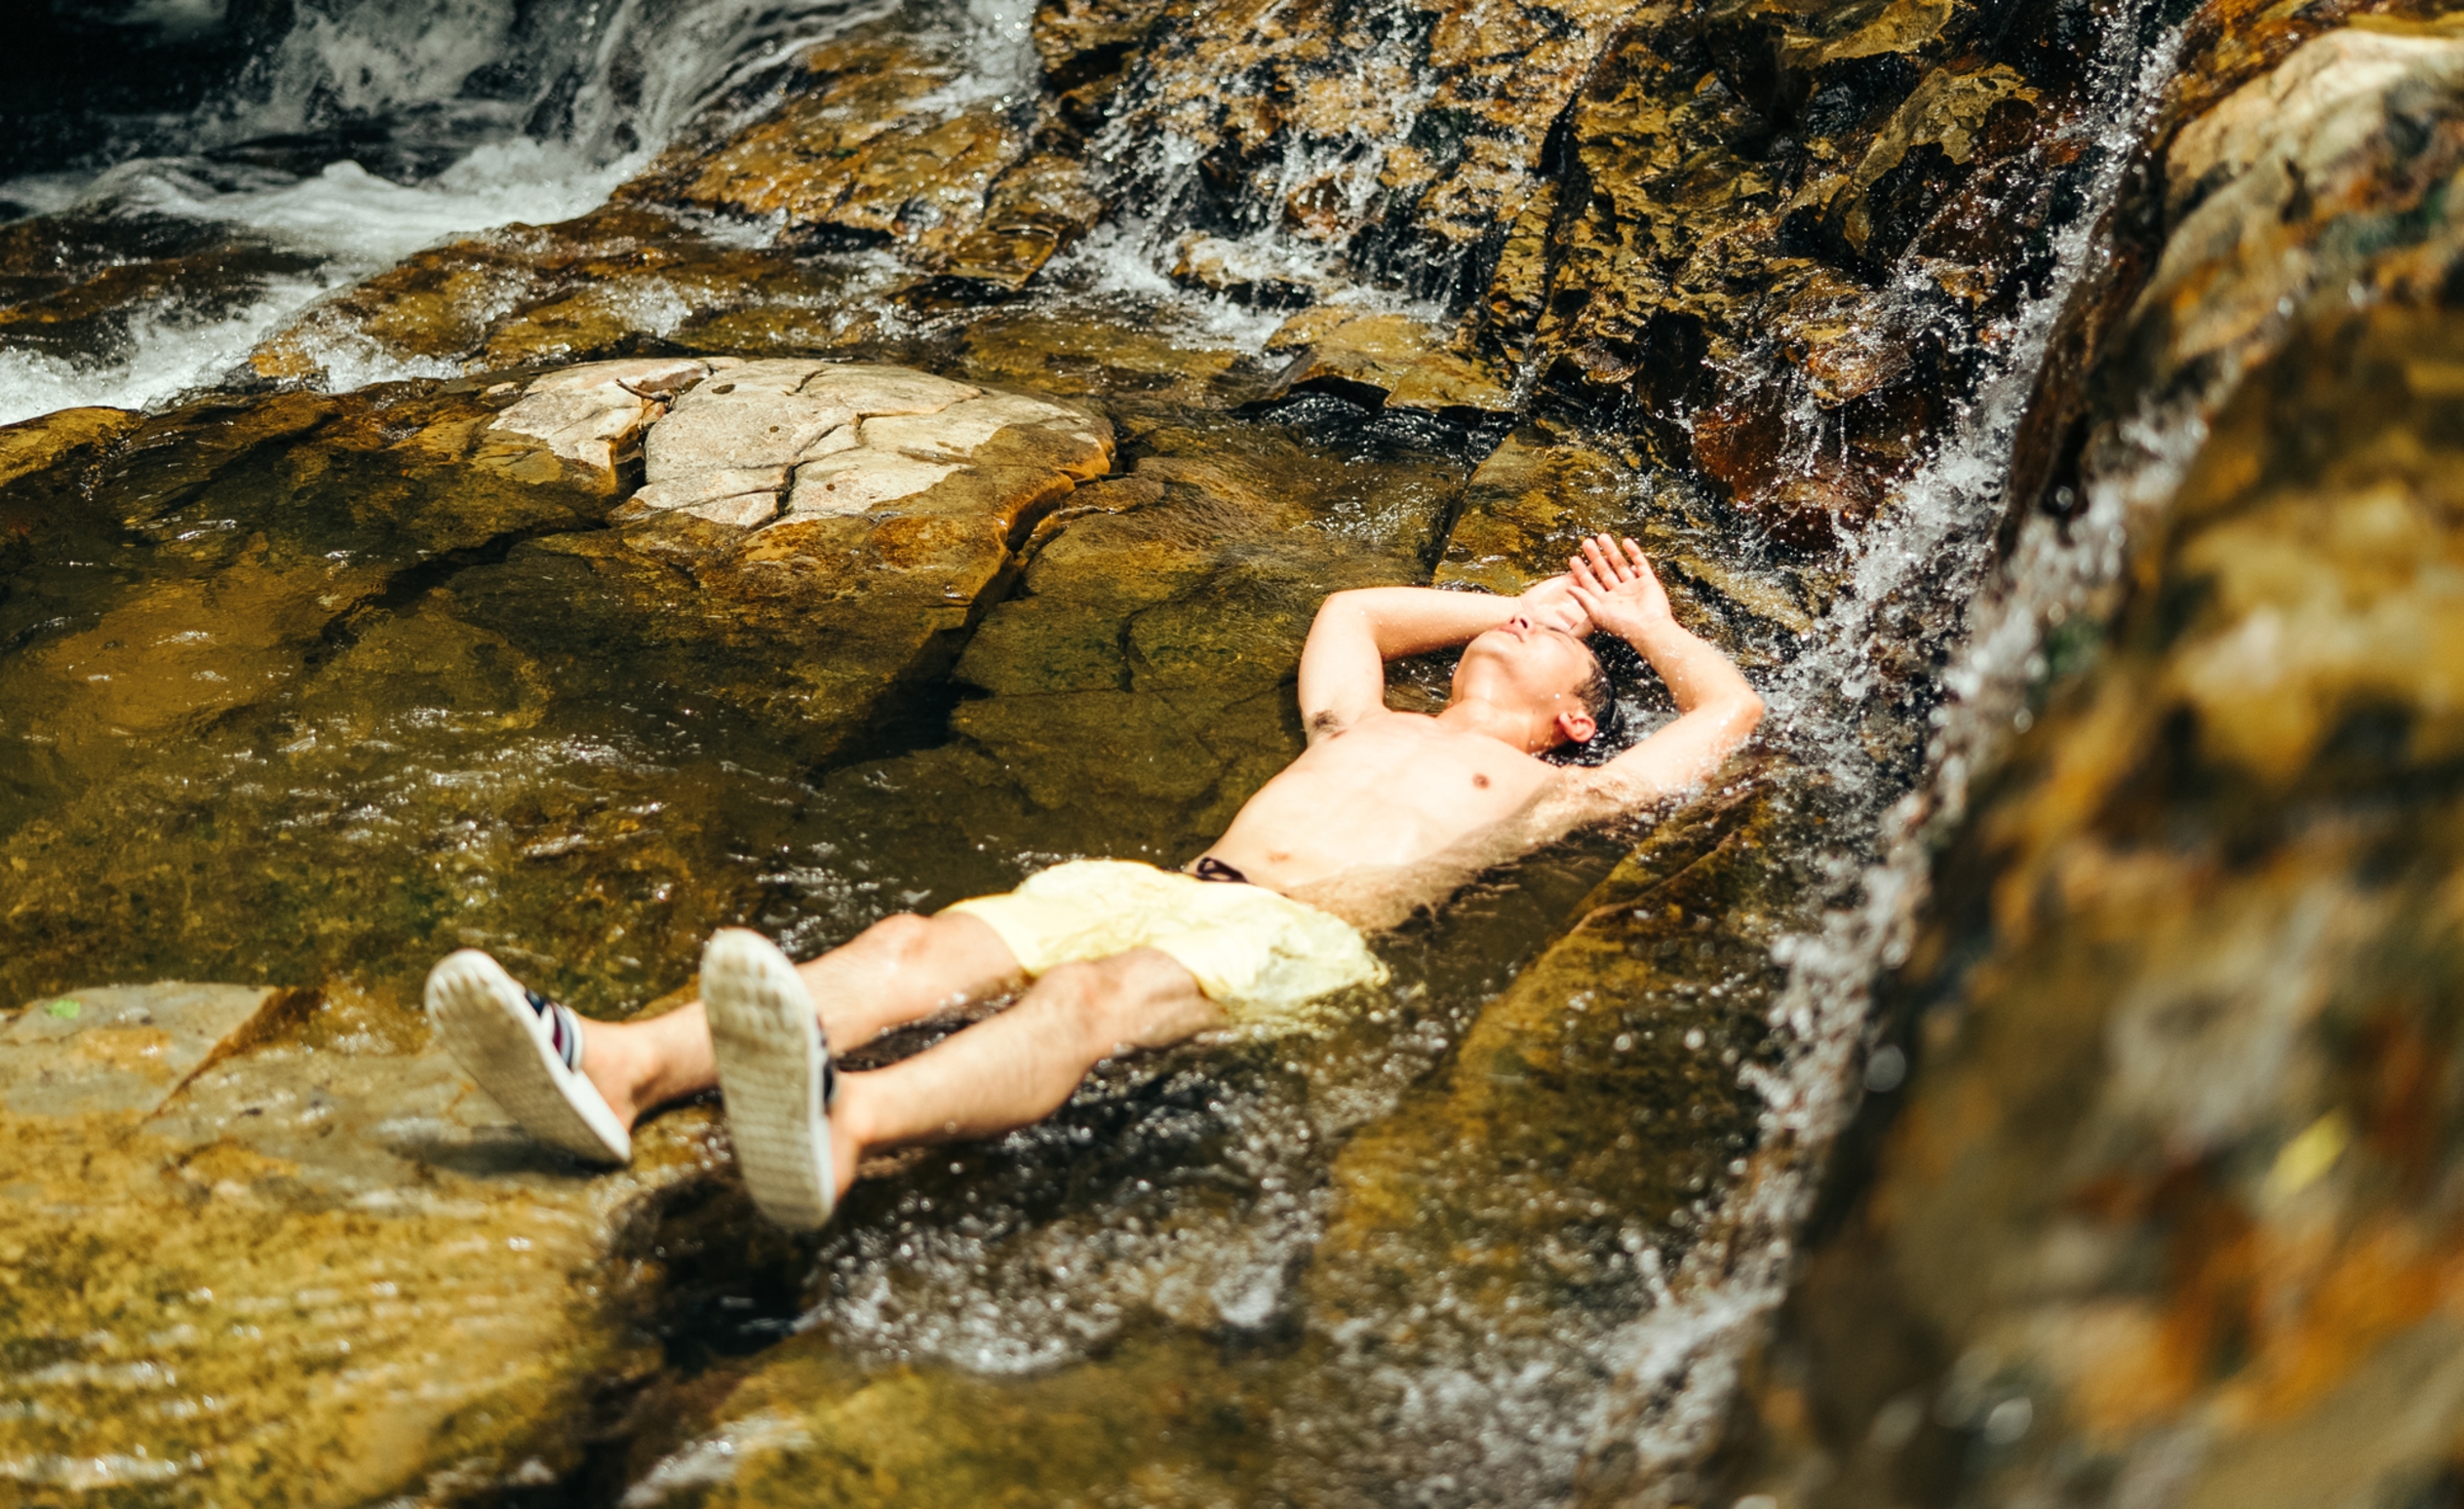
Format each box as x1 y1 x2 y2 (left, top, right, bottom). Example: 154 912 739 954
426 948 633 1164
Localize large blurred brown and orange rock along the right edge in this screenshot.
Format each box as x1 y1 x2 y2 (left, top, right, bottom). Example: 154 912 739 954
1740 22 2464 1506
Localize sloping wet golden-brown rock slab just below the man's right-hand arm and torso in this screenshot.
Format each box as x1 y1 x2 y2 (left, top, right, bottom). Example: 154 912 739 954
1294 775 1794 1504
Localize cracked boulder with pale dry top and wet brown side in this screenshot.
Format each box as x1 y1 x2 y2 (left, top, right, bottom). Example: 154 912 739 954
455 360 1112 760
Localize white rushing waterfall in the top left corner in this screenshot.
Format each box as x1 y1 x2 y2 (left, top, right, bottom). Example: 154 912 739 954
0 0 906 423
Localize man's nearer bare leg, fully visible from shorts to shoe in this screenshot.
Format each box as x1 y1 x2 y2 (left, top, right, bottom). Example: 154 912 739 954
831 948 1225 1194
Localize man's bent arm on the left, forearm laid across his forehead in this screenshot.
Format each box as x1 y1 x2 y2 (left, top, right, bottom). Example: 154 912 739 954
1301 576 1589 744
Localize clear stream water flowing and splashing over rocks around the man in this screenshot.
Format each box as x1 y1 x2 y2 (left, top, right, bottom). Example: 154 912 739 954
0 0 2198 1504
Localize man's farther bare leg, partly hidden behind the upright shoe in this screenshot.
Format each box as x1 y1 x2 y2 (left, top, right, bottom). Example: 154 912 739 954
581 910 1020 1132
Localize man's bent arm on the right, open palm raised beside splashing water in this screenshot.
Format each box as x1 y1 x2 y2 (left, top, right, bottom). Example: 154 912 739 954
1567 534 1762 822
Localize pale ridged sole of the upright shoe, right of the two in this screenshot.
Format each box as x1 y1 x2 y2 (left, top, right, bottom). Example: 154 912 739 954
702 928 838 1231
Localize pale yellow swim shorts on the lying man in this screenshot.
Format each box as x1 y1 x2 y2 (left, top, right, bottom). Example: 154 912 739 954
949 859 1388 1034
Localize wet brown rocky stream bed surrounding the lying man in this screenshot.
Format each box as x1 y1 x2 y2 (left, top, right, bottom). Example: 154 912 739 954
14 0 2464 1509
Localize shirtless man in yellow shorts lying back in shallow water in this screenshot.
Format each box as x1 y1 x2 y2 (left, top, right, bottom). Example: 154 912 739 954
426 537 1762 1228
